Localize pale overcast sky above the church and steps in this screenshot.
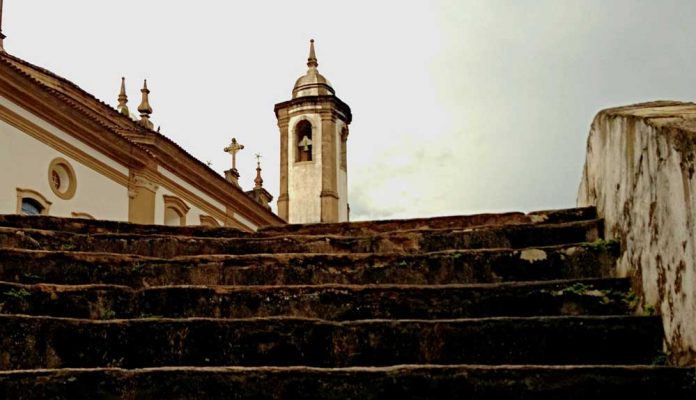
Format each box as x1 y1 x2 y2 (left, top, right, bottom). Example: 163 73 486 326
3 0 696 219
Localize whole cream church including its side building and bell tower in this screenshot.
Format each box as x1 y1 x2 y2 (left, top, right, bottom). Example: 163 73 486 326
0 3 351 231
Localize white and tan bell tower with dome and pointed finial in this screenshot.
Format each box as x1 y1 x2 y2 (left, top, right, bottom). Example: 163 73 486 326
275 40 353 224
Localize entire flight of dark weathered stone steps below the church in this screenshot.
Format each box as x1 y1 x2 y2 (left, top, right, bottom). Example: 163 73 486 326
0 208 696 399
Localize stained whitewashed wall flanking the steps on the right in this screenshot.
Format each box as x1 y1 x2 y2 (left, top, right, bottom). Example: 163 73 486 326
578 101 696 365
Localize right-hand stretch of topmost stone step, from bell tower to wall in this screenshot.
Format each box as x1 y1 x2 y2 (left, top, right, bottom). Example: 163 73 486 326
256 207 597 236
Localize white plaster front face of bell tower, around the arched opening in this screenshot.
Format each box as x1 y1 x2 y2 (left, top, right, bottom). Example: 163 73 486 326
288 114 322 224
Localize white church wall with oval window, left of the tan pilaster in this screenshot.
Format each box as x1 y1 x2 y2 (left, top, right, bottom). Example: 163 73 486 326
0 97 128 221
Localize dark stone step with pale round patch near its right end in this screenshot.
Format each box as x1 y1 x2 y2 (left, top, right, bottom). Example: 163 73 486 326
0 245 617 287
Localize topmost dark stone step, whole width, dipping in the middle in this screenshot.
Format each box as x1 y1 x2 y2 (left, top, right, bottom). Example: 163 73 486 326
0 207 597 237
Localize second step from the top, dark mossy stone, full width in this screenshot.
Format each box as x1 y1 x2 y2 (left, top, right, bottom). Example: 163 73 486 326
0 220 601 258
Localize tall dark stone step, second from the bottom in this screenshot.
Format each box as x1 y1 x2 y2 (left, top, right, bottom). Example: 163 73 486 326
0 315 663 370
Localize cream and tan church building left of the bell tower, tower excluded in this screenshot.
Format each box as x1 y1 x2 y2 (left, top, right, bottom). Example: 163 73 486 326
0 22 285 231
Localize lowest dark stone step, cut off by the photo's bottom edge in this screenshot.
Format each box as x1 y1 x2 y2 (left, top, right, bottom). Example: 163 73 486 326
0 365 696 400
